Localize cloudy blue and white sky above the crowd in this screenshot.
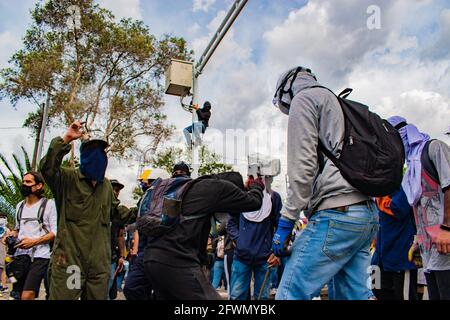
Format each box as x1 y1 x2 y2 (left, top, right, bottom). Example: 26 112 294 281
0 0 450 204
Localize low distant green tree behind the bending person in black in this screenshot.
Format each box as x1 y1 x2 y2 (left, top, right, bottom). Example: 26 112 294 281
133 146 233 200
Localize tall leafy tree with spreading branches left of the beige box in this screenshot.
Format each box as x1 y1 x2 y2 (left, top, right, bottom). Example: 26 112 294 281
0 0 192 158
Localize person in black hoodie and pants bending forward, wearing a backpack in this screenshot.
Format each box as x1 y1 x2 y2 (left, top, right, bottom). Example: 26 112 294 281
144 172 263 300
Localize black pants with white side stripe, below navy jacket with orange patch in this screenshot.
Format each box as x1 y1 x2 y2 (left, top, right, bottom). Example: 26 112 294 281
373 270 418 300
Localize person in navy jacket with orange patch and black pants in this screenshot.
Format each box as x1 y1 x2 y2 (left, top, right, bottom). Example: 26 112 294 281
372 189 418 300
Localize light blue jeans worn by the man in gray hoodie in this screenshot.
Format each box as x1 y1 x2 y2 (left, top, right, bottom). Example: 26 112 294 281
276 203 378 300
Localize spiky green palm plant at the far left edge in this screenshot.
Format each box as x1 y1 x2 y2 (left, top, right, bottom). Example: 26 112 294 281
0 147 53 223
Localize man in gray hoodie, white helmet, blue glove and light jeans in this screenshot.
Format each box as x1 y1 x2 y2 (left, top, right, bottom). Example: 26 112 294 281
273 67 378 300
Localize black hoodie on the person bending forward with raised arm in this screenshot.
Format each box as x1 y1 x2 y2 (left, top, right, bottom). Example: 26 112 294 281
144 172 263 268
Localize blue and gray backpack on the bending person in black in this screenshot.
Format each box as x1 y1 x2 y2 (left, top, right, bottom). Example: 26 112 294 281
136 177 207 237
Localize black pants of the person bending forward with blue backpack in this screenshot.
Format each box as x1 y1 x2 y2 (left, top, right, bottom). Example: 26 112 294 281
145 261 222 300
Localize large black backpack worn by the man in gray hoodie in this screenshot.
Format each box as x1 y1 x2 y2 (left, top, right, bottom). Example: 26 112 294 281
314 86 405 197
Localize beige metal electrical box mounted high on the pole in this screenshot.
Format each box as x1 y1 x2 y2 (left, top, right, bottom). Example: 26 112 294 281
165 59 193 96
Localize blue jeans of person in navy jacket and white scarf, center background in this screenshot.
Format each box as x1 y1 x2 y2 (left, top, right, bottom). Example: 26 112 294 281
230 258 270 300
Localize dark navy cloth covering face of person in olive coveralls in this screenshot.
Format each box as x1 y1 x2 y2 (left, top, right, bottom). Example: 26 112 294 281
80 148 108 182
